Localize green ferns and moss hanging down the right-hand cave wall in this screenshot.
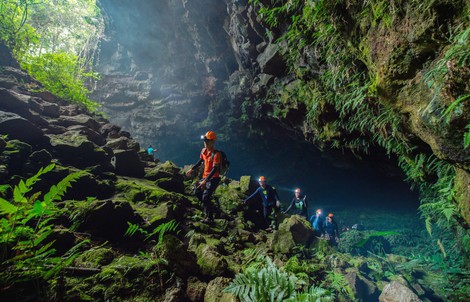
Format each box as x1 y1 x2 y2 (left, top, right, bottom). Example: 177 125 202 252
251 0 470 292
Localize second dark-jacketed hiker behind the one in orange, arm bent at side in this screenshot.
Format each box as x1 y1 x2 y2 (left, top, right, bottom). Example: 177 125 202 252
243 176 280 231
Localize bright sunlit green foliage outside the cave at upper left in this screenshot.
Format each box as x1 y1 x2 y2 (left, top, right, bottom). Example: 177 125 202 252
0 0 104 111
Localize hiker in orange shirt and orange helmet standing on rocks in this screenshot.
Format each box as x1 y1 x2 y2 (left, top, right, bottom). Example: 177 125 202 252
186 131 221 223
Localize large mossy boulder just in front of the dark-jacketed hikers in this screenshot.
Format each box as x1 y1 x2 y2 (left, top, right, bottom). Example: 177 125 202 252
271 215 315 254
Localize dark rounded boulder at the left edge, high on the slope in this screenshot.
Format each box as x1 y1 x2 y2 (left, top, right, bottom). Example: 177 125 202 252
0 110 45 145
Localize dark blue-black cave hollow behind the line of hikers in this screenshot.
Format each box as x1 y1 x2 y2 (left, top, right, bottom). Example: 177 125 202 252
152 123 419 228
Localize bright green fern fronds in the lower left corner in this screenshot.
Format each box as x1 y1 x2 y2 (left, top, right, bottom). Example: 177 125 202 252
0 164 84 284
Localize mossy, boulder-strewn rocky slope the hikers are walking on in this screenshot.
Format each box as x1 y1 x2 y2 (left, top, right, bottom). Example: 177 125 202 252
0 50 456 301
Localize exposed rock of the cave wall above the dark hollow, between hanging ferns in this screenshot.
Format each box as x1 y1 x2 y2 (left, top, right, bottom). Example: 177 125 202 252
94 0 470 226
